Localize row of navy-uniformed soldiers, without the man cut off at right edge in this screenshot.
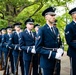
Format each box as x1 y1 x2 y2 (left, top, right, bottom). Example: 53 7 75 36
0 7 63 75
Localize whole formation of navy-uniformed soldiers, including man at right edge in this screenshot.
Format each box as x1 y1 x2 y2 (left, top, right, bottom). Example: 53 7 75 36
0 7 76 75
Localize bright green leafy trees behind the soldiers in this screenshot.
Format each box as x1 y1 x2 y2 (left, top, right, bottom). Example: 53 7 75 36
0 0 72 50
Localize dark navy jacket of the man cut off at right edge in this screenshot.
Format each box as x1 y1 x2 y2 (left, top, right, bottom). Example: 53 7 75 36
65 21 76 57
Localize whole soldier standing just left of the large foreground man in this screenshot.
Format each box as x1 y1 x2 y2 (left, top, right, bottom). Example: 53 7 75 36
20 18 37 75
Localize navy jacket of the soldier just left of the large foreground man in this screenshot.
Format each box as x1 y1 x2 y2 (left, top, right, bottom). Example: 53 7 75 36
19 30 35 61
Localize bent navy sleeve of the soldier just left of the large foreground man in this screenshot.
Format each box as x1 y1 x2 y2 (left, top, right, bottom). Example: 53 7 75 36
19 33 32 53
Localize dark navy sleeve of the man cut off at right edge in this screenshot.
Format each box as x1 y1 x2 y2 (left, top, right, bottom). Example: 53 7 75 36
65 26 76 49
